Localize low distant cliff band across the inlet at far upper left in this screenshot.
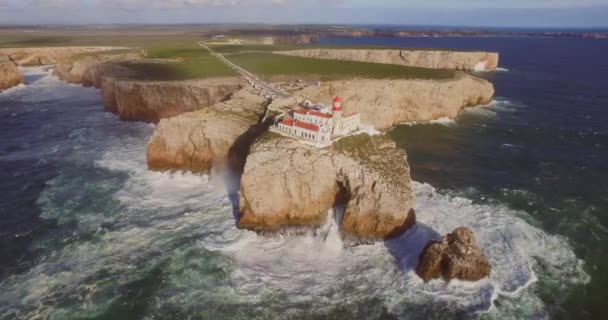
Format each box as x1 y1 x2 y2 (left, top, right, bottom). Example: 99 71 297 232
0 47 116 66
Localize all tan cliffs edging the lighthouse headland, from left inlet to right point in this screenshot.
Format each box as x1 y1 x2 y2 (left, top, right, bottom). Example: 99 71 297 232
14 47 494 258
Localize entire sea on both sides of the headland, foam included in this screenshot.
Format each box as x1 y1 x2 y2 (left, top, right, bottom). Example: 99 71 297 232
0 37 608 320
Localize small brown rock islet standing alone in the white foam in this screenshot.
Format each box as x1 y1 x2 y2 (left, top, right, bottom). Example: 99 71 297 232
416 227 492 281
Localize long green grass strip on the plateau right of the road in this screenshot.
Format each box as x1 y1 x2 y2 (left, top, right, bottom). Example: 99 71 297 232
228 53 454 79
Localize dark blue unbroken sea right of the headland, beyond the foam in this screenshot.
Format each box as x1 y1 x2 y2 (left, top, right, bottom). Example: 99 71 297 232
323 37 608 319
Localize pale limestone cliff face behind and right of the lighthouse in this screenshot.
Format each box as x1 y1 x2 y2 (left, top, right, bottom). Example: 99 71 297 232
298 73 494 129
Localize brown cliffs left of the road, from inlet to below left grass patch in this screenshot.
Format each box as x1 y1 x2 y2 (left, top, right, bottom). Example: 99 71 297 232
55 53 243 123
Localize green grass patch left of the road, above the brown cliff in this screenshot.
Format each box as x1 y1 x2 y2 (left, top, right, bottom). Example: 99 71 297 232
125 57 238 81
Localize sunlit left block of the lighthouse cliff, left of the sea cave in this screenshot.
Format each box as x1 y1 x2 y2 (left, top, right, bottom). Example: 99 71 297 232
239 133 339 231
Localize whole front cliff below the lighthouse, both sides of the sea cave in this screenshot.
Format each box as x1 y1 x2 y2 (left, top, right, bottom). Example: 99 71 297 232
239 133 415 241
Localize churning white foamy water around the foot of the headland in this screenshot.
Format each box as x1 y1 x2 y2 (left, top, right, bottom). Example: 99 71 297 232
0 66 588 319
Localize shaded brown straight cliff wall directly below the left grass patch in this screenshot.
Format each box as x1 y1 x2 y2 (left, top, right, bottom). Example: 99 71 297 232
113 77 243 123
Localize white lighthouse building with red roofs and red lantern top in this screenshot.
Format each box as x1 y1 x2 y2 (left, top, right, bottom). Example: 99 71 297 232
271 97 361 144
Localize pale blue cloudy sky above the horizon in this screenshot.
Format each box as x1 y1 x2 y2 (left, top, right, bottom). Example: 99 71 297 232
0 0 608 28
